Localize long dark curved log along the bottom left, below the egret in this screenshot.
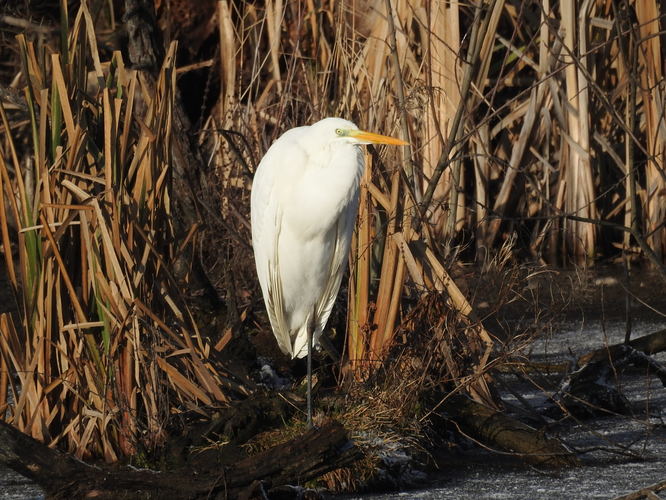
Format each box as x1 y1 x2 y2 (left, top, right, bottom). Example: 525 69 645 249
0 421 360 500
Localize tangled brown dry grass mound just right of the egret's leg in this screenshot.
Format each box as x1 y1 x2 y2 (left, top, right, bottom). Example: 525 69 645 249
323 292 492 491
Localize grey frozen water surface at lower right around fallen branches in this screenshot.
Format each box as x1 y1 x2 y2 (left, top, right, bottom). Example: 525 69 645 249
341 320 666 500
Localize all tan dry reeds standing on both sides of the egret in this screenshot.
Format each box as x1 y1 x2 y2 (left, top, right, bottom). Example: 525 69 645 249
0 0 666 468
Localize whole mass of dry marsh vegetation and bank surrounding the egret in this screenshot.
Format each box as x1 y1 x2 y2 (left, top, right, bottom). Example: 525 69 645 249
0 0 666 497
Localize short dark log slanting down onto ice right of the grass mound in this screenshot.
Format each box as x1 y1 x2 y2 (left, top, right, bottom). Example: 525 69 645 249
443 396 578 467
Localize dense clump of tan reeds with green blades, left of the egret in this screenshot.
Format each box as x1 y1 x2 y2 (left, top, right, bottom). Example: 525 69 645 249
0 2 232 461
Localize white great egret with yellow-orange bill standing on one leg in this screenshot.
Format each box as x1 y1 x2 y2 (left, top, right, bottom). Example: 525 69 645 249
251 118 407 425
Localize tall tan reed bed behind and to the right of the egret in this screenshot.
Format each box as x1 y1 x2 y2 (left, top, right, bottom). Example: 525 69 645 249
208 0 666 380
